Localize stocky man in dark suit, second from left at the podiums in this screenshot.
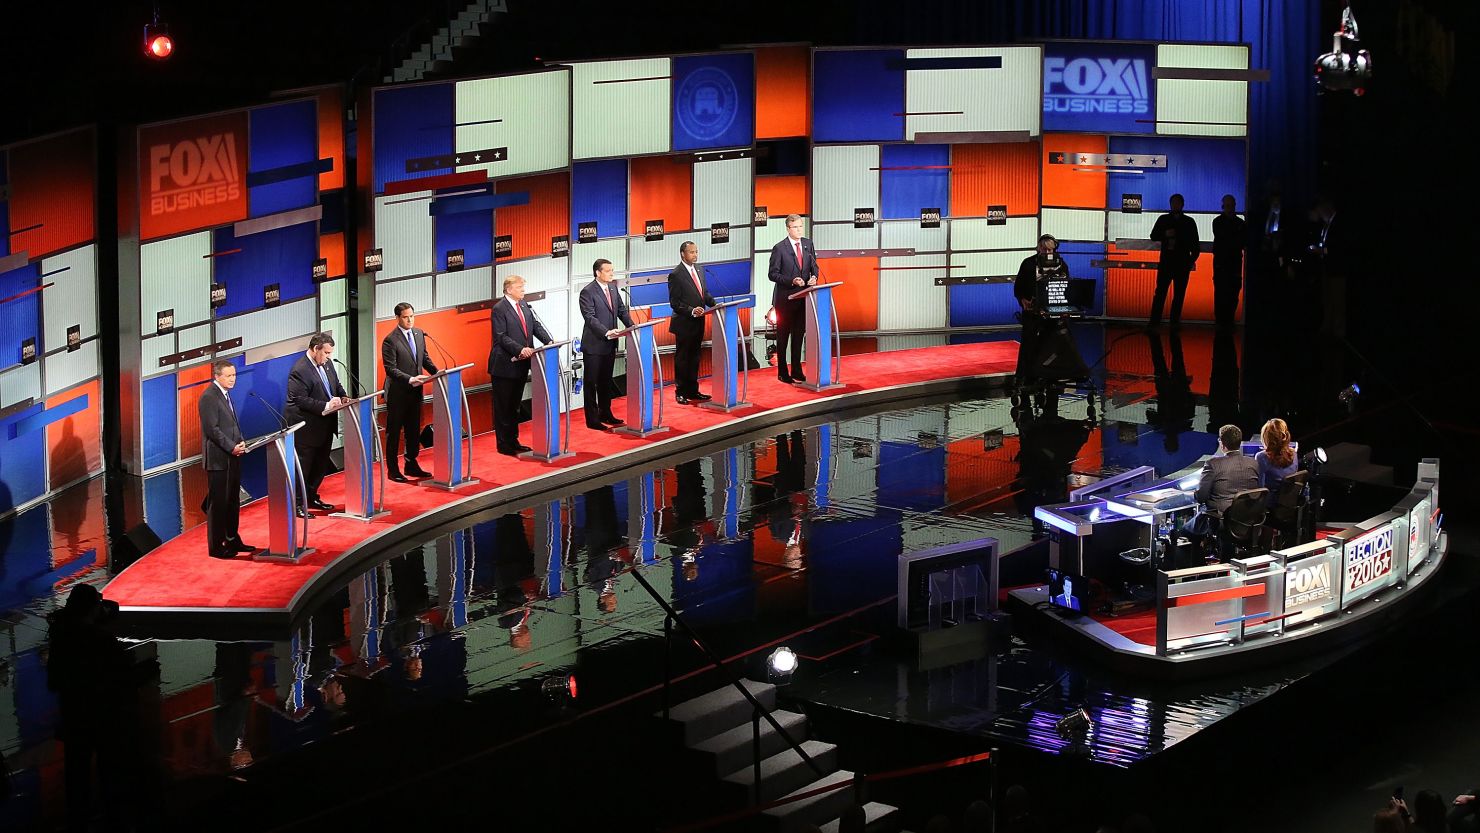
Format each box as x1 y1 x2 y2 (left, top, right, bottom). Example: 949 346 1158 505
284 333 349 512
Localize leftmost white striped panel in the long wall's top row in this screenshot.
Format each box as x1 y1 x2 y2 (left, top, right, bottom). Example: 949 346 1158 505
454 67 570 176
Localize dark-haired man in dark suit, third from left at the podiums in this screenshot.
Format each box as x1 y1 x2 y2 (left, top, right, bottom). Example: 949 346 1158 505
380 300 437 482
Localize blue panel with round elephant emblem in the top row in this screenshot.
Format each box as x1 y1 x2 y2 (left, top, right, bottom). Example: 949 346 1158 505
673 52 755 151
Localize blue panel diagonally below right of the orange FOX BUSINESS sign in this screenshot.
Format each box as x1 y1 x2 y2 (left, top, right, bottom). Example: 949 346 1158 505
212 223 318 318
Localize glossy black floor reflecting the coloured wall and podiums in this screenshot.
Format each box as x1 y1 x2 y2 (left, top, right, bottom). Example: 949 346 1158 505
0 324 1474 824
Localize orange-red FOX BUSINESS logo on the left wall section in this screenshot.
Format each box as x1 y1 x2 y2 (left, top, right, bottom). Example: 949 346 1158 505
149 133 241 216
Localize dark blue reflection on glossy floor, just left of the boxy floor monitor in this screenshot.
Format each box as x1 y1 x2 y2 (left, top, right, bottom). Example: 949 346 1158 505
804 510 904 616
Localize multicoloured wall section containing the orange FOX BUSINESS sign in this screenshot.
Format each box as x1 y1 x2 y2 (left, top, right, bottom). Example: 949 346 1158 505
118 87 349 506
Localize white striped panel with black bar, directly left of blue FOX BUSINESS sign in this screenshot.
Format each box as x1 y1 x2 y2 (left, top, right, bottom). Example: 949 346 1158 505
904 46 1043 139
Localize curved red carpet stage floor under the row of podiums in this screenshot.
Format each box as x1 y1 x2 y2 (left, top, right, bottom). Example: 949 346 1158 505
104 342 1017 616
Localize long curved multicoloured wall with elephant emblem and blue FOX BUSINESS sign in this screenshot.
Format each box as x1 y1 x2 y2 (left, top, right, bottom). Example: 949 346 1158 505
361 41 1249 411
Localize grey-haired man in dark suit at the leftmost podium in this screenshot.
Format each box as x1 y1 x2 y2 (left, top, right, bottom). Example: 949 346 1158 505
197 360 256 558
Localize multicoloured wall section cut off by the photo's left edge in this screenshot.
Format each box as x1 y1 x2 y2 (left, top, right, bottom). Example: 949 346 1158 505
0 129 102 515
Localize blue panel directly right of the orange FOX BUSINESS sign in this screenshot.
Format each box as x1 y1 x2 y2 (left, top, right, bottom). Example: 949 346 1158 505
247 99 318 217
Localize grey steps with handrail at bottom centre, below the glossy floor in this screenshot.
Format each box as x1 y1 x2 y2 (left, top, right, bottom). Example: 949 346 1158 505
657 679 901 833
